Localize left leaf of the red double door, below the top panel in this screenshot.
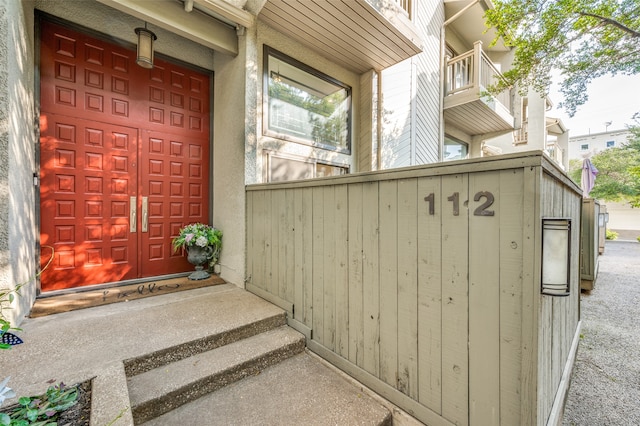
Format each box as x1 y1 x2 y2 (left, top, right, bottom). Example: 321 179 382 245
40 114 138 291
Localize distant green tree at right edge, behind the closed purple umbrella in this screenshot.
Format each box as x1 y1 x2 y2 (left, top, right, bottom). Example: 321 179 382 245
569 122 640 207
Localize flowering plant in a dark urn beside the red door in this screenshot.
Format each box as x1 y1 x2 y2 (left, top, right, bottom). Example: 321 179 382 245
172 223 222 280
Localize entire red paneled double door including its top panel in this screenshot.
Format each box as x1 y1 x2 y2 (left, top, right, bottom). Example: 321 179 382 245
40 22 210 291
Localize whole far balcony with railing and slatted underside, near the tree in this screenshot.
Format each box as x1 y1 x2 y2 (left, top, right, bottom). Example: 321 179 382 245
444 41 514 135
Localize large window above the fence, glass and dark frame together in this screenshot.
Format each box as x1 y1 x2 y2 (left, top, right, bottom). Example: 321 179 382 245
264 46 351 154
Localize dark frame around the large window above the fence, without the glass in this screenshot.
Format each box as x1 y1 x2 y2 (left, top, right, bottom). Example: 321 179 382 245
262 44 353 155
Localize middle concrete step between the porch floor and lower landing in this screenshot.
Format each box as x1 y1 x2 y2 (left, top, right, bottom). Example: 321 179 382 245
127 326 305 424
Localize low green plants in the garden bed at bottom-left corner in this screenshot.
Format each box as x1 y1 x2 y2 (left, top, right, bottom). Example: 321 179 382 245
0 383 78 426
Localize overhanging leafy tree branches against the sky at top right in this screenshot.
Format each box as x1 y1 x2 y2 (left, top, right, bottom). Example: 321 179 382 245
486 0 640 116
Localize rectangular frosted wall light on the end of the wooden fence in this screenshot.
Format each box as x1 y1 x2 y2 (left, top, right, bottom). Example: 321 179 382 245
542 218 571 296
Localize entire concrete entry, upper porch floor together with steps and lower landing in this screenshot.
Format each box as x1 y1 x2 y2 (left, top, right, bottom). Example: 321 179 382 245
7 284 397 426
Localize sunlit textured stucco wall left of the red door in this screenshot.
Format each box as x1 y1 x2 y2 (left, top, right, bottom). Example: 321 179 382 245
0 0 36 325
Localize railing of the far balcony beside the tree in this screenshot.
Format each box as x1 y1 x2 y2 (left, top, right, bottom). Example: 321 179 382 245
446 41 511 111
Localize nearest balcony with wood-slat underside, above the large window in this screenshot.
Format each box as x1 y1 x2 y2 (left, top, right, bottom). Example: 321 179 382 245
258 0 422 74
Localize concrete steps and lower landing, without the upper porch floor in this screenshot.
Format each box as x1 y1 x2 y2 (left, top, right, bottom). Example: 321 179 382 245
119 288 391 426
